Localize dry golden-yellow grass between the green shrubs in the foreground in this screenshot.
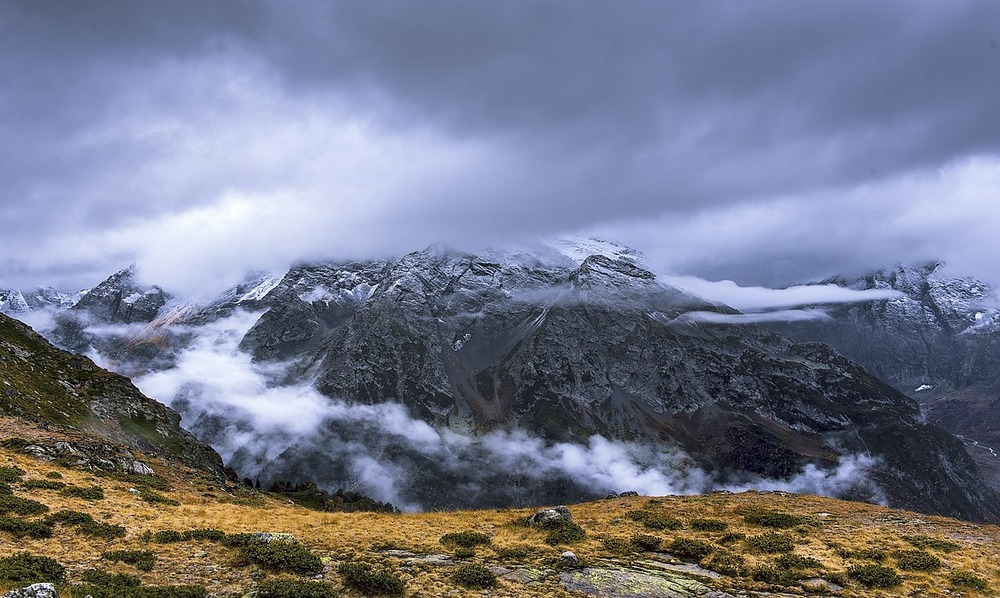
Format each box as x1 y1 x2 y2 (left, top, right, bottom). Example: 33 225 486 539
0 420 1000 596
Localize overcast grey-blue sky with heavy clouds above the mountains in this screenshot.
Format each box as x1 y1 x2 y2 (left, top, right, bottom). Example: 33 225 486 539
0 0 1000 290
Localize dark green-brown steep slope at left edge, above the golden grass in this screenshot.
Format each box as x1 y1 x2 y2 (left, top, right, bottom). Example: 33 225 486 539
0 314 224 477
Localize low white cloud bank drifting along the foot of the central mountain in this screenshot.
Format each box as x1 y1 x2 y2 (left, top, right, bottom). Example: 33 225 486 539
123 313 883 510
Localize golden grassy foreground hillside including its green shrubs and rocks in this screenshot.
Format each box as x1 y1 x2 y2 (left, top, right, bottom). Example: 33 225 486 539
0 417 1000 598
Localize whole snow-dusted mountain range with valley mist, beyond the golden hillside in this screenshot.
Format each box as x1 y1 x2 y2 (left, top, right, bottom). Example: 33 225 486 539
3 241 1000 520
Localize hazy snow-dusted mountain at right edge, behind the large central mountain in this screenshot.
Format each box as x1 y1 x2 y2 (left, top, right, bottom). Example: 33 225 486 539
773 263 1000 488
